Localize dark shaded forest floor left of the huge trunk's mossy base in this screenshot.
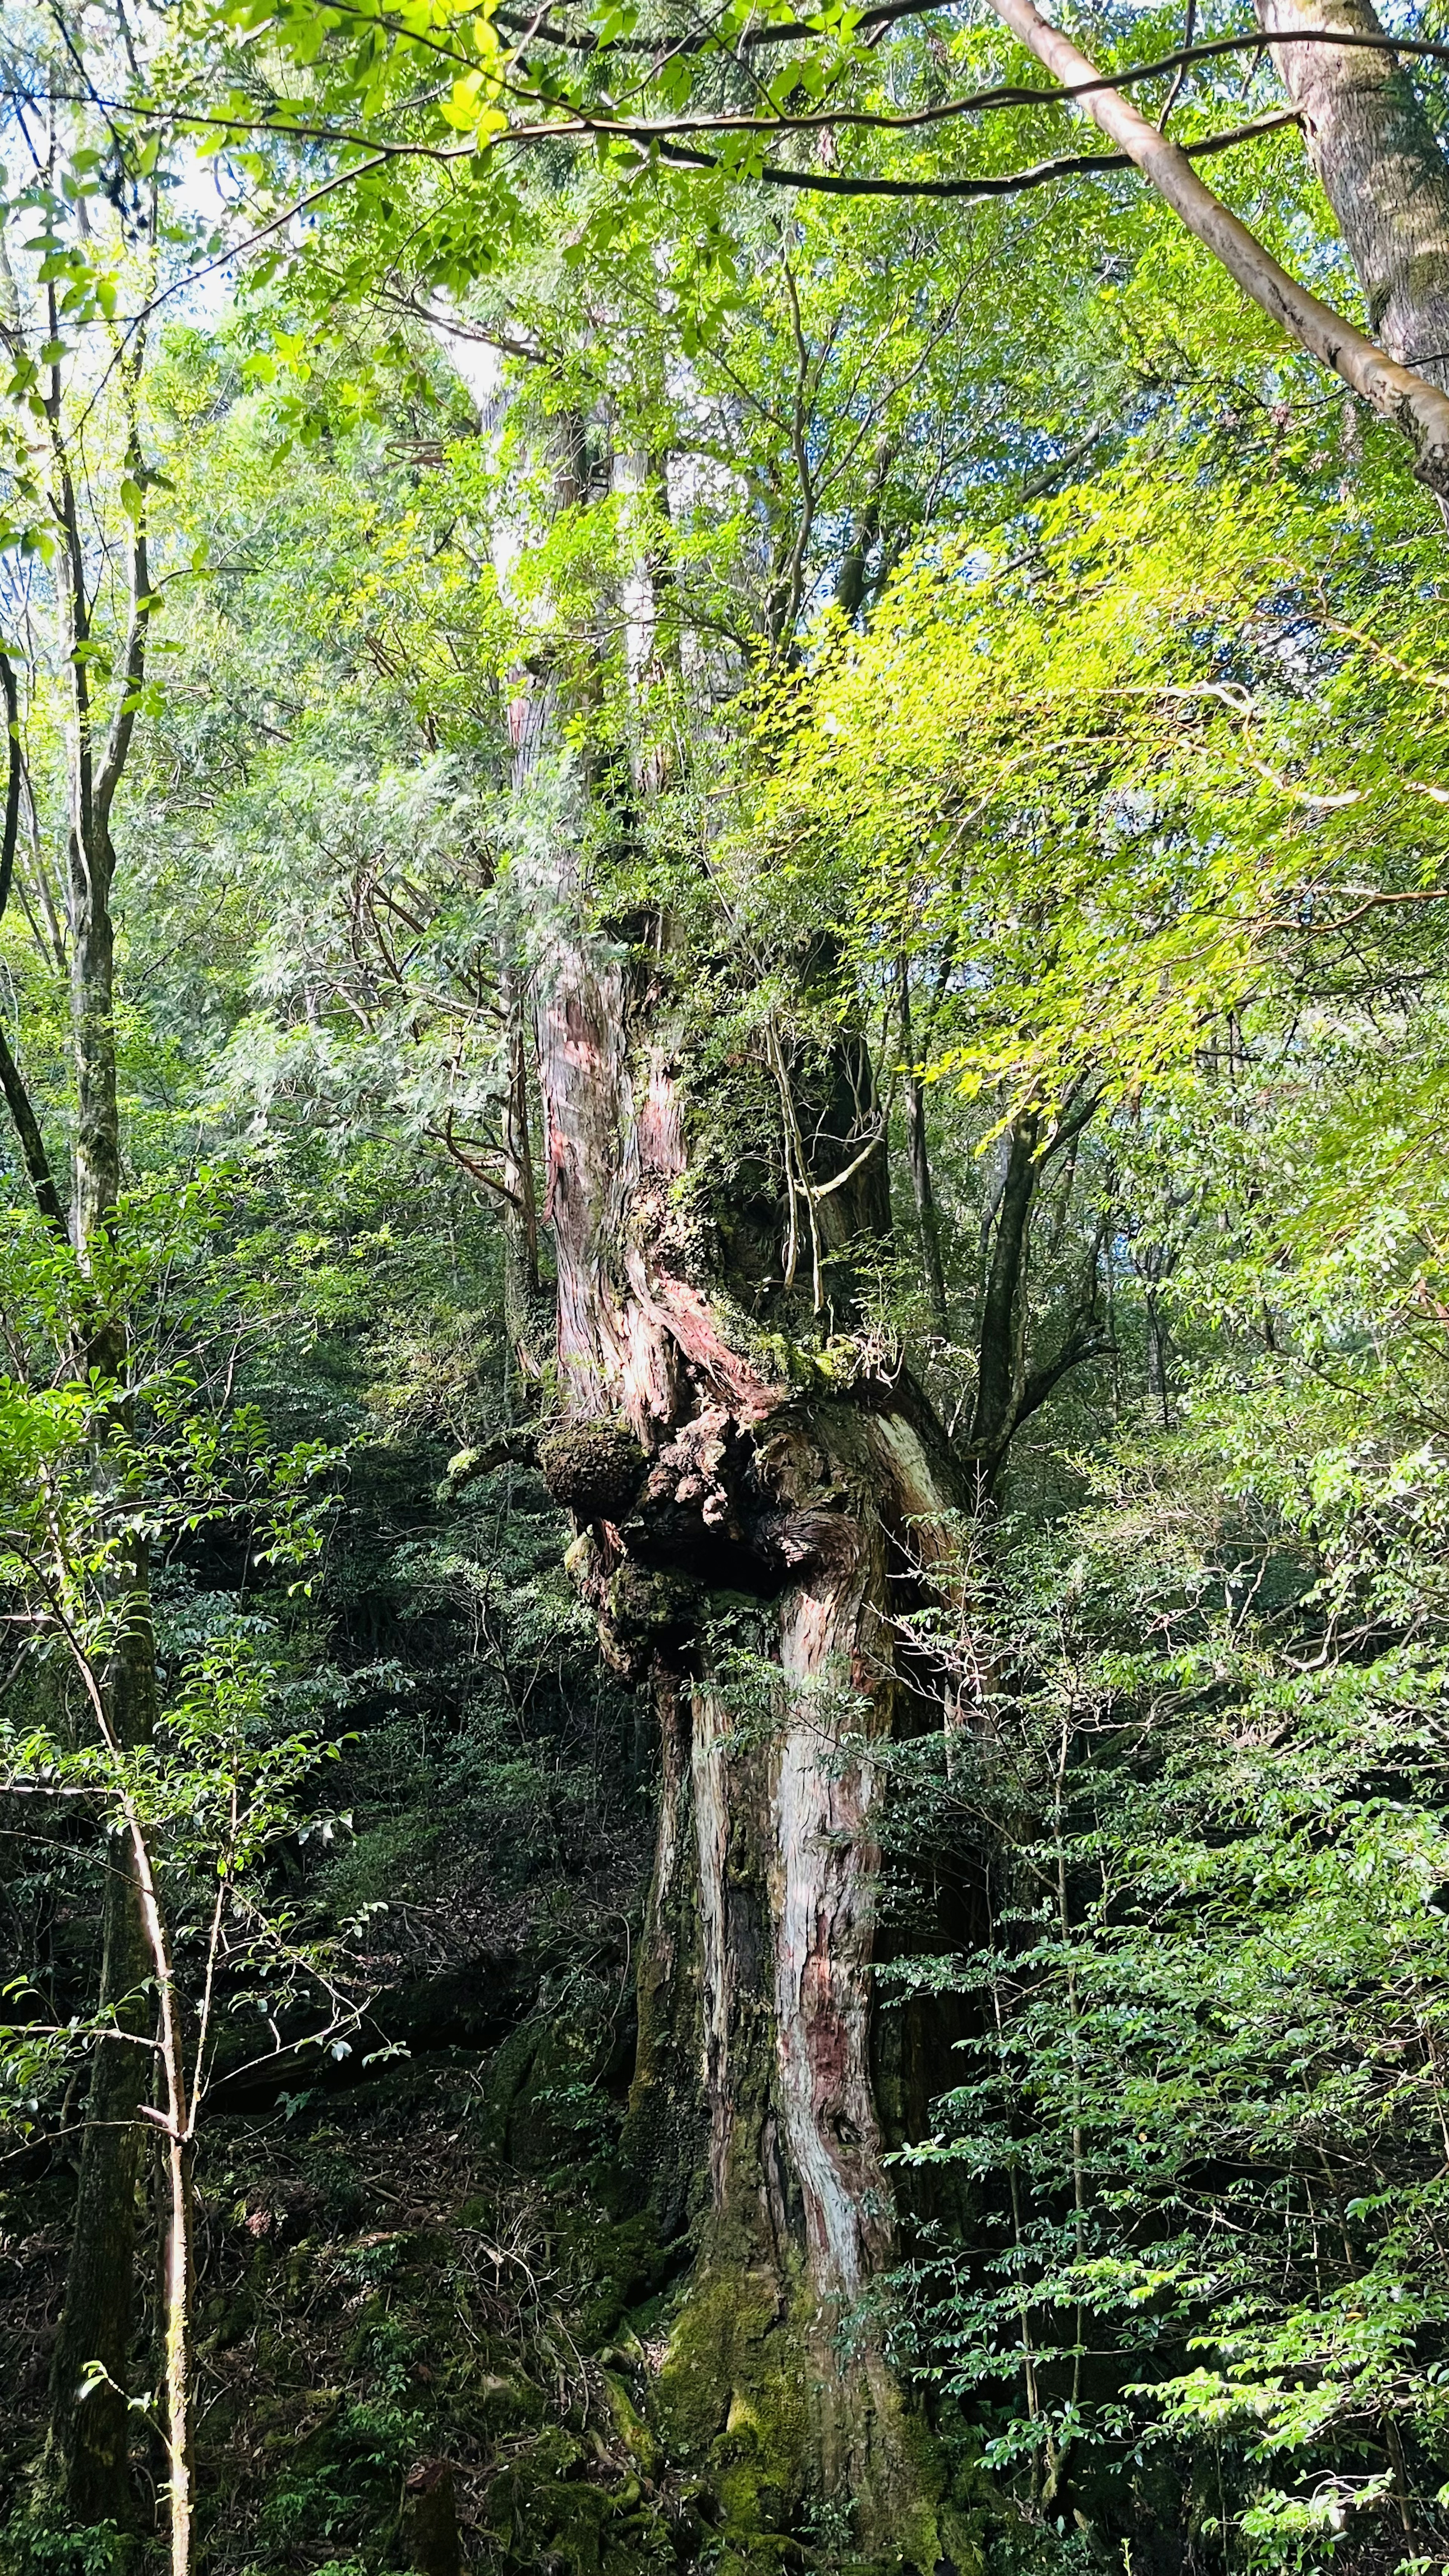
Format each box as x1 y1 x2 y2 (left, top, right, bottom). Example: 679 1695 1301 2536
0 2030 704 2576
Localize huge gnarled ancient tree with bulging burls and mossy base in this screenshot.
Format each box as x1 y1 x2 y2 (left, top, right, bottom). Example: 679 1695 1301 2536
451 312 1091 2534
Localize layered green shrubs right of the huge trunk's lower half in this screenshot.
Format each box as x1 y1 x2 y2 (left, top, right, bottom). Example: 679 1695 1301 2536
881 1396 1449 2568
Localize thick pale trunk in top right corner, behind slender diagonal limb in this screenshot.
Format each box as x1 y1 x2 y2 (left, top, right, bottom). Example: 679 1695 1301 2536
1258 0 1449 386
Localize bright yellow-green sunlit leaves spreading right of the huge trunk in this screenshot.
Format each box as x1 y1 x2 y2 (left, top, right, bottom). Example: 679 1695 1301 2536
743 440 1444 1141
